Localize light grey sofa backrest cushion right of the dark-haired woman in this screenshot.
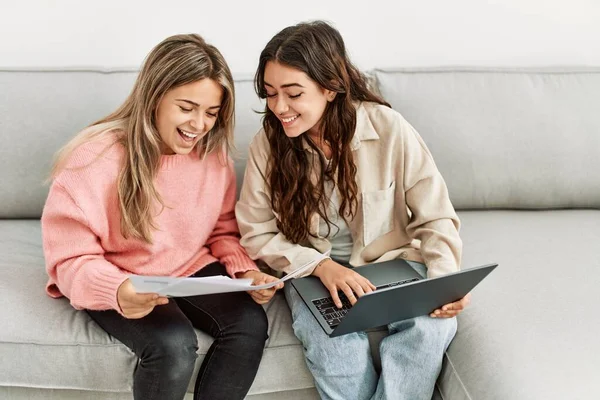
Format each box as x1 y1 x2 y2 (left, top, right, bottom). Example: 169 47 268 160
374 68 600 209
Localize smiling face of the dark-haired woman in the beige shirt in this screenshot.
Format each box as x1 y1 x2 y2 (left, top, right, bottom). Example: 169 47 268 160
264 61 335 138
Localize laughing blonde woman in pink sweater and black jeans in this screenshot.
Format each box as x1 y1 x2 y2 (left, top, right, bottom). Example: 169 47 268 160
42 35 276 400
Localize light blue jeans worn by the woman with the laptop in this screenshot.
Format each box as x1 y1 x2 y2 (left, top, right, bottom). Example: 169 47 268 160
285 263 457 400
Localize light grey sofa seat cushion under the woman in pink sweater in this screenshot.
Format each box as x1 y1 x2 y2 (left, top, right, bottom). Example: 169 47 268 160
0 220 314 394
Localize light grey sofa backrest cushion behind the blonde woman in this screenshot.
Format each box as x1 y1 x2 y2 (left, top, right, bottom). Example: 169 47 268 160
0 70 264 218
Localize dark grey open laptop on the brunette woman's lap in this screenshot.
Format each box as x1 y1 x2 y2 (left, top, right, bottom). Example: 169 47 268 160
291 259 498 337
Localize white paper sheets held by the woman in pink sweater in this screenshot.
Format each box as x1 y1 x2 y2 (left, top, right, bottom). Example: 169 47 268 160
129 259 321 297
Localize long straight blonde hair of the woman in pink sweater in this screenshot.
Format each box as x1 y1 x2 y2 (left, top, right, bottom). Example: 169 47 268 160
50 34 235 243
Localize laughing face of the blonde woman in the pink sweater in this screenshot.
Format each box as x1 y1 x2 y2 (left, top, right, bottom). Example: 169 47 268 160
156 78 223 154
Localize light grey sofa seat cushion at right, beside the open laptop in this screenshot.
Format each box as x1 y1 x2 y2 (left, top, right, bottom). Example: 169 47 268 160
439 210 600 400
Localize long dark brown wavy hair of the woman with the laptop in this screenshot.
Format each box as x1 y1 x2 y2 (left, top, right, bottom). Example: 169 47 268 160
254 21 389 243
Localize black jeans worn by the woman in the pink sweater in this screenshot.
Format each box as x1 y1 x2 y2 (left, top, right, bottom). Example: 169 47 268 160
87 263 268 400
